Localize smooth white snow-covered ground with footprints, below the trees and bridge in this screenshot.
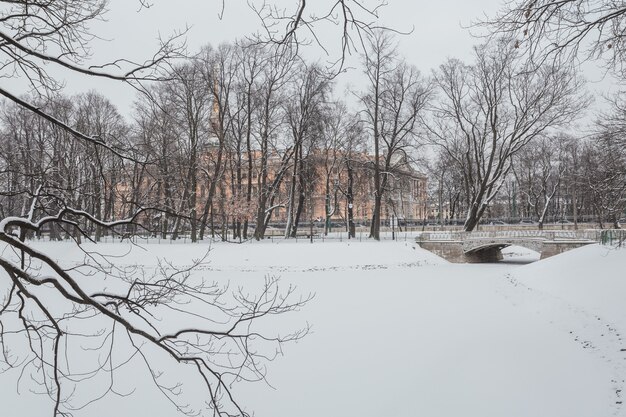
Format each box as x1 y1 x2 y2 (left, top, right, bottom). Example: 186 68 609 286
0 240 626 417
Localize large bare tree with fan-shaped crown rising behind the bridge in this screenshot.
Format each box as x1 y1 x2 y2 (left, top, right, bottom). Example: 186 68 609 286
428 41 588 231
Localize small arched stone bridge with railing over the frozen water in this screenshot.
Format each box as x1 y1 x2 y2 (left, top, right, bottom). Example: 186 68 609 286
416 230 600 263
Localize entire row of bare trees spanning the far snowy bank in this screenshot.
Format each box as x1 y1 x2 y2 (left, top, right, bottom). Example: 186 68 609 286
0 32 624 237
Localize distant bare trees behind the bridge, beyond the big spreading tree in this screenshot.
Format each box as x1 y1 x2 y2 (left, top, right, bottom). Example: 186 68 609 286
431 128 626 228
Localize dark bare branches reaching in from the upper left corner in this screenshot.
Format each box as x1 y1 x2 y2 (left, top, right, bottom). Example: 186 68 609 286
0 0 182 148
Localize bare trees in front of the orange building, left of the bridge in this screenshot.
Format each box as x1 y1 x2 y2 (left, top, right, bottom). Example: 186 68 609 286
0 37 432 241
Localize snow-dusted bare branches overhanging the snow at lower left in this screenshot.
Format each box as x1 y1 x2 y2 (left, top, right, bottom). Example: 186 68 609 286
0 221 308 416
